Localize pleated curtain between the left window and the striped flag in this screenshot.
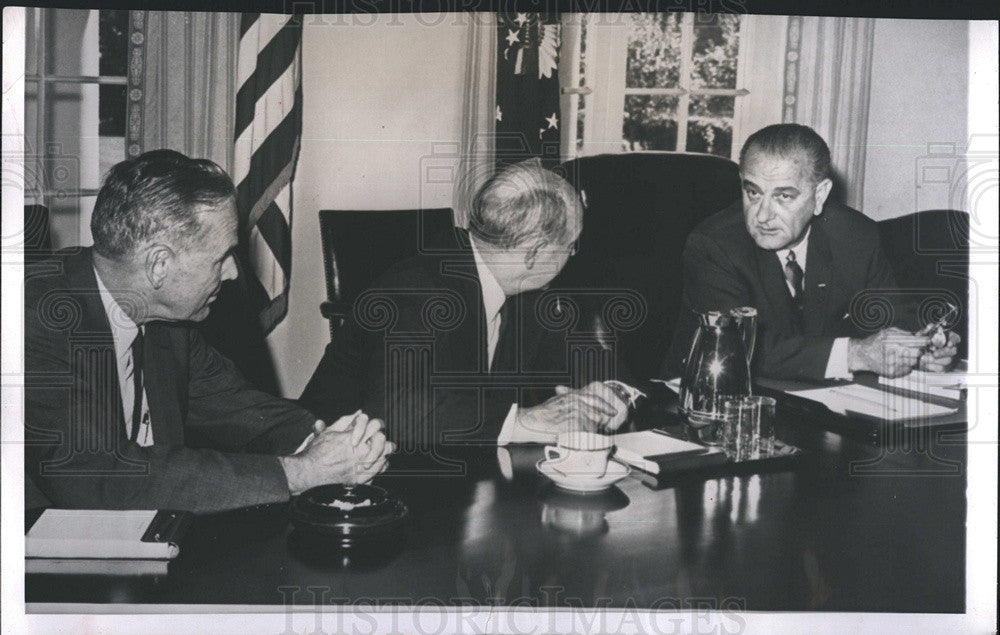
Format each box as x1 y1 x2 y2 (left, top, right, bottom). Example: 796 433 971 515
126 11 240 174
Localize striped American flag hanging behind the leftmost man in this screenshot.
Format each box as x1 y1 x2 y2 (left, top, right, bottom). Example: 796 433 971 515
233 13 302 333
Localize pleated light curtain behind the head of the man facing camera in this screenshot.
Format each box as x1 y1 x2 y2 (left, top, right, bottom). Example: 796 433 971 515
783 16 875 209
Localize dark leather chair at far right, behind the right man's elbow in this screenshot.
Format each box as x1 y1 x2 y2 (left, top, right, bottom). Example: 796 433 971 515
878 210 972 359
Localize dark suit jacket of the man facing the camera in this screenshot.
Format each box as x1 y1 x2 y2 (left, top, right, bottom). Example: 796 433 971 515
664 202 911 379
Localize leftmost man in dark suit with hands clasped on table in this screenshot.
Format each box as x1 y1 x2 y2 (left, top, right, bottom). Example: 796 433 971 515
25 150 392 512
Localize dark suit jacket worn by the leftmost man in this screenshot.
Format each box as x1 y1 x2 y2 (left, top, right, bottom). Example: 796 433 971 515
25 249 315 512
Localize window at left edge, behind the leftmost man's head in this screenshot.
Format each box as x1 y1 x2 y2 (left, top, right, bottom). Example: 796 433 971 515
24 8 128 248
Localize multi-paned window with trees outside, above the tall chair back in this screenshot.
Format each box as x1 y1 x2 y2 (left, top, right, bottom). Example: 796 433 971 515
560 12 749 157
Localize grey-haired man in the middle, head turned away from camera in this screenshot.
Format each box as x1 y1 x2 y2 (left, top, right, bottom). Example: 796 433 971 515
301 160 622 454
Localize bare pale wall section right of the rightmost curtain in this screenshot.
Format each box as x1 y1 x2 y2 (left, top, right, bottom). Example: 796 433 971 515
863 19 969 220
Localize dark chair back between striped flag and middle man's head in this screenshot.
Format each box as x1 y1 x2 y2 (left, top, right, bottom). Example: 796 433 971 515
319 208 455 340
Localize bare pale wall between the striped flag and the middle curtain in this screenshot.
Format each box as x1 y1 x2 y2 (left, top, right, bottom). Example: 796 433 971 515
268 14 471 397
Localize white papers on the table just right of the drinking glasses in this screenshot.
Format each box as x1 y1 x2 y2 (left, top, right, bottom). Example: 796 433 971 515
788 384 958 421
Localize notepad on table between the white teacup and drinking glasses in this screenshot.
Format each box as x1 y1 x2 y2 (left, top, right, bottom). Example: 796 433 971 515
615 430 727 474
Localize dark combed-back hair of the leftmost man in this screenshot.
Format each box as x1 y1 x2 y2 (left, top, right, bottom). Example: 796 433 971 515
90 150 236 259
